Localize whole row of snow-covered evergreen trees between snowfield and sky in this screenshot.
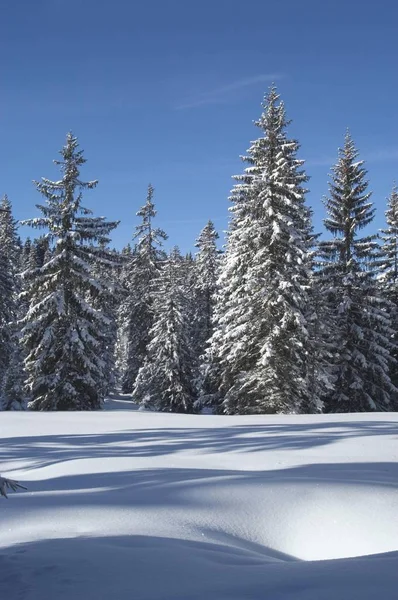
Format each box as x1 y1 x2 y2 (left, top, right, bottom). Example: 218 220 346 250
0 87 398 414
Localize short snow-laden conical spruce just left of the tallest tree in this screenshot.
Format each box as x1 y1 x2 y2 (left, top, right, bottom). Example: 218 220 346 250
133 249 196 413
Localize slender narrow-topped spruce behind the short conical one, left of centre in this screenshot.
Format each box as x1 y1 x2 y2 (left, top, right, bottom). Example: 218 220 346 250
119 185 167 393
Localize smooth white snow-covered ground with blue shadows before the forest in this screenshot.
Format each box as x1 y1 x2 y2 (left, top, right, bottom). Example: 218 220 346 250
0 398 398 600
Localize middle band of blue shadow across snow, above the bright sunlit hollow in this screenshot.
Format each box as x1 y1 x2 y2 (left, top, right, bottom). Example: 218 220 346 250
13 462 398 500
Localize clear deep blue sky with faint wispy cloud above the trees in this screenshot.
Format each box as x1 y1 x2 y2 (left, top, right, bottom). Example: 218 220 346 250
0 0 398 251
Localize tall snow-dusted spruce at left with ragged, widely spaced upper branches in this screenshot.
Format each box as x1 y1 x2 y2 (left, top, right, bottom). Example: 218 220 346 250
23 133 117 410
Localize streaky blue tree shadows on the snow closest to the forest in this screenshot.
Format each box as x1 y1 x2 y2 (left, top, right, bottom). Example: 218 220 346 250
2 417 398 468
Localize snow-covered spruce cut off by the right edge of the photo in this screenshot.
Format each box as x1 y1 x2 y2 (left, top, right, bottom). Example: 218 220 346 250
379 185 398 400
